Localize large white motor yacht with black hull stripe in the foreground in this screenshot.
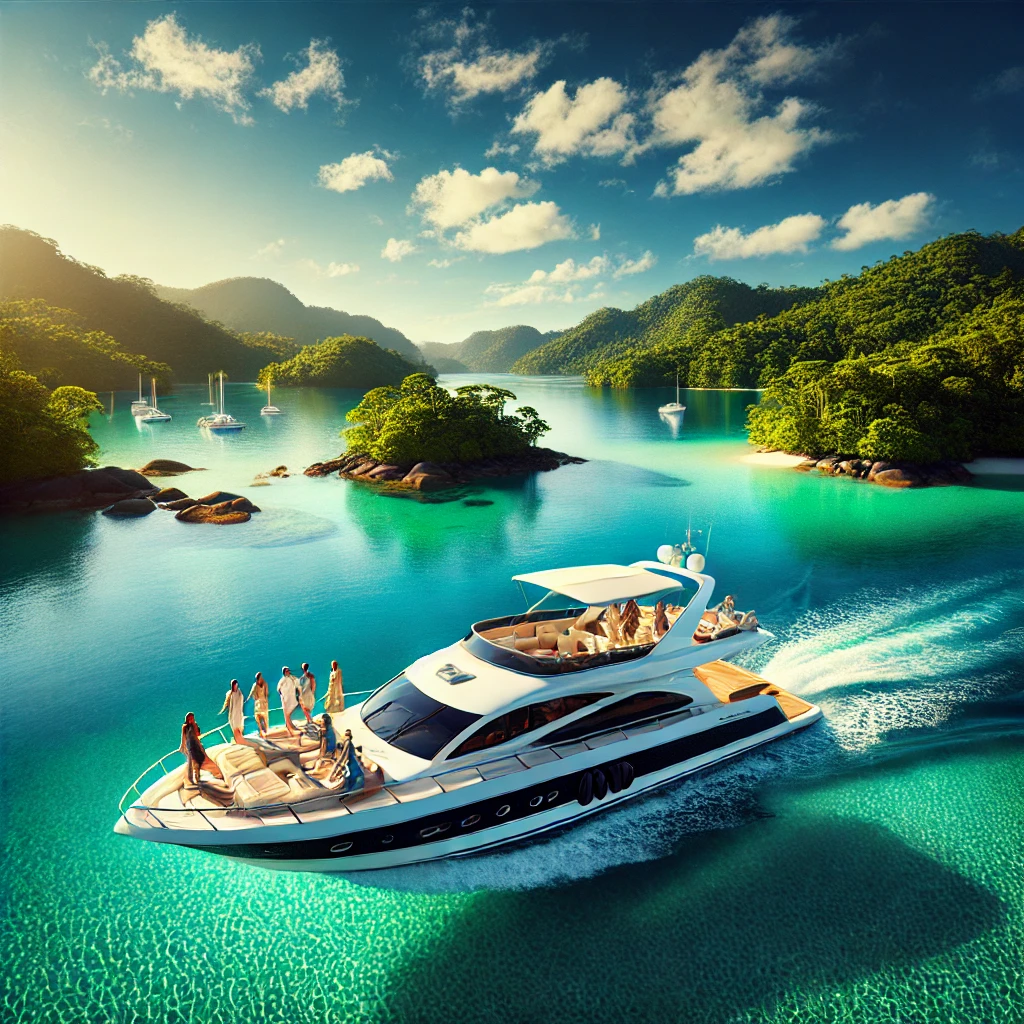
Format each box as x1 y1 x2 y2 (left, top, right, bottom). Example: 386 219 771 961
115 558 821 871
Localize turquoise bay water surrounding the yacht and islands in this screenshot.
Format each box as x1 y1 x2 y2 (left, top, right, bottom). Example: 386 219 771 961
0 378 1024 1024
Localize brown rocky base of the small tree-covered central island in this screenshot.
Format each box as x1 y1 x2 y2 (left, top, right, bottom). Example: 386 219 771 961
305 447 587 492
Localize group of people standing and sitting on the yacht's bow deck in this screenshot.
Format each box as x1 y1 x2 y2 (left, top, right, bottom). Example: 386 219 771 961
180 662 362 788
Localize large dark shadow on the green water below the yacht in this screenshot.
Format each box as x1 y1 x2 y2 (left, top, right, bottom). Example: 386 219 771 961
376 817 1005 1024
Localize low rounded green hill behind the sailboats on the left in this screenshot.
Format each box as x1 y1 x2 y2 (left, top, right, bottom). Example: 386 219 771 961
257 335 432 390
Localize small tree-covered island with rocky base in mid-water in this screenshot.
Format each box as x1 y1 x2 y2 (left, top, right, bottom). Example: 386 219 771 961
305 373 586 490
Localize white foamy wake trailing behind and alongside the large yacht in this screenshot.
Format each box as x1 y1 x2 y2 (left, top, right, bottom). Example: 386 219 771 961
348 573 1024 893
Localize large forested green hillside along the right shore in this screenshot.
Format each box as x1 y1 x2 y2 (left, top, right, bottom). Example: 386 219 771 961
514 228 1024 463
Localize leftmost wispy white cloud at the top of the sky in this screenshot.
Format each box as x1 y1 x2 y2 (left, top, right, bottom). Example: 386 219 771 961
88 13 260 124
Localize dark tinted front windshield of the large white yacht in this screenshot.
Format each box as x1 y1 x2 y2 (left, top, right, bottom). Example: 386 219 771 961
360 676 480 761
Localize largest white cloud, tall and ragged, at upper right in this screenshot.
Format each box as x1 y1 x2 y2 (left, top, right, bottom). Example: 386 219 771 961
644 14 837 196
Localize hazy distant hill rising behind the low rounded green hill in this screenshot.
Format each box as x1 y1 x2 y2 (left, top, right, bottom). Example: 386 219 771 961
157 278 423 362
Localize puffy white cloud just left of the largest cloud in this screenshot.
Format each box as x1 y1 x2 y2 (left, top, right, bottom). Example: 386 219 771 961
511 78 636 165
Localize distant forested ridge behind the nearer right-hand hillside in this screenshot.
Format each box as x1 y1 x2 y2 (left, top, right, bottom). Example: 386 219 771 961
512 276 818 386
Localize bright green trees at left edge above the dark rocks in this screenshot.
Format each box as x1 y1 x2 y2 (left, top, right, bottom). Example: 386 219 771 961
0 351 102 482
